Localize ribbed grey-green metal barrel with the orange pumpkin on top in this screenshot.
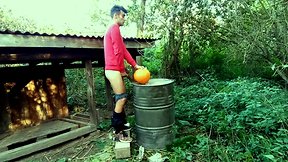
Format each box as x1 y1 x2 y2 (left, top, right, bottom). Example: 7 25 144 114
133 78 175 149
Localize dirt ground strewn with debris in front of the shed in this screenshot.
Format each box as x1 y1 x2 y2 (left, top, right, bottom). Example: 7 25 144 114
13 128 160 162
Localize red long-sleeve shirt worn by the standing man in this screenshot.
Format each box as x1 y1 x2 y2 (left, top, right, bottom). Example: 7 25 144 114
104 24 136 73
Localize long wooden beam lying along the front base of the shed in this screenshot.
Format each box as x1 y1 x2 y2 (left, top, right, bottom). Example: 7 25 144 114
0 125 96 161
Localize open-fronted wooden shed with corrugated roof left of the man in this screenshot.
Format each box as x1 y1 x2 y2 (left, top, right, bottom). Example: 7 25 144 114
0 31 155 161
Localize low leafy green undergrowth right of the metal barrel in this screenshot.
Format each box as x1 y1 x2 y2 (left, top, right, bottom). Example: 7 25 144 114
171 75 288 161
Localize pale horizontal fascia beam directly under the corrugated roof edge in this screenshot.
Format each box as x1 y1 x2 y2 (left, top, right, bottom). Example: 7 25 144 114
0 34 155 49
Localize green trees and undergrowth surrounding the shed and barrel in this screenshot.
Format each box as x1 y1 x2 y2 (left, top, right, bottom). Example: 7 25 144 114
0 0 288 162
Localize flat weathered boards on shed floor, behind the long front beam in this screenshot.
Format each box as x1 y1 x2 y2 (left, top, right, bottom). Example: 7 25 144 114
0 120 78 148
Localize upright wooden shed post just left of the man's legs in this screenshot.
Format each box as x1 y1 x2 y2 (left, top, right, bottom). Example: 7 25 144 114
85 60 99 127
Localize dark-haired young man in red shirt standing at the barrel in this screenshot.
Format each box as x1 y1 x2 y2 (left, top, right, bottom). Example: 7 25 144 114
104 5 143 141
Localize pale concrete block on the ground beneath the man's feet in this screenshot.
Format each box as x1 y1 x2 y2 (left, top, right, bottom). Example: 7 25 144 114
114 142 131 159
